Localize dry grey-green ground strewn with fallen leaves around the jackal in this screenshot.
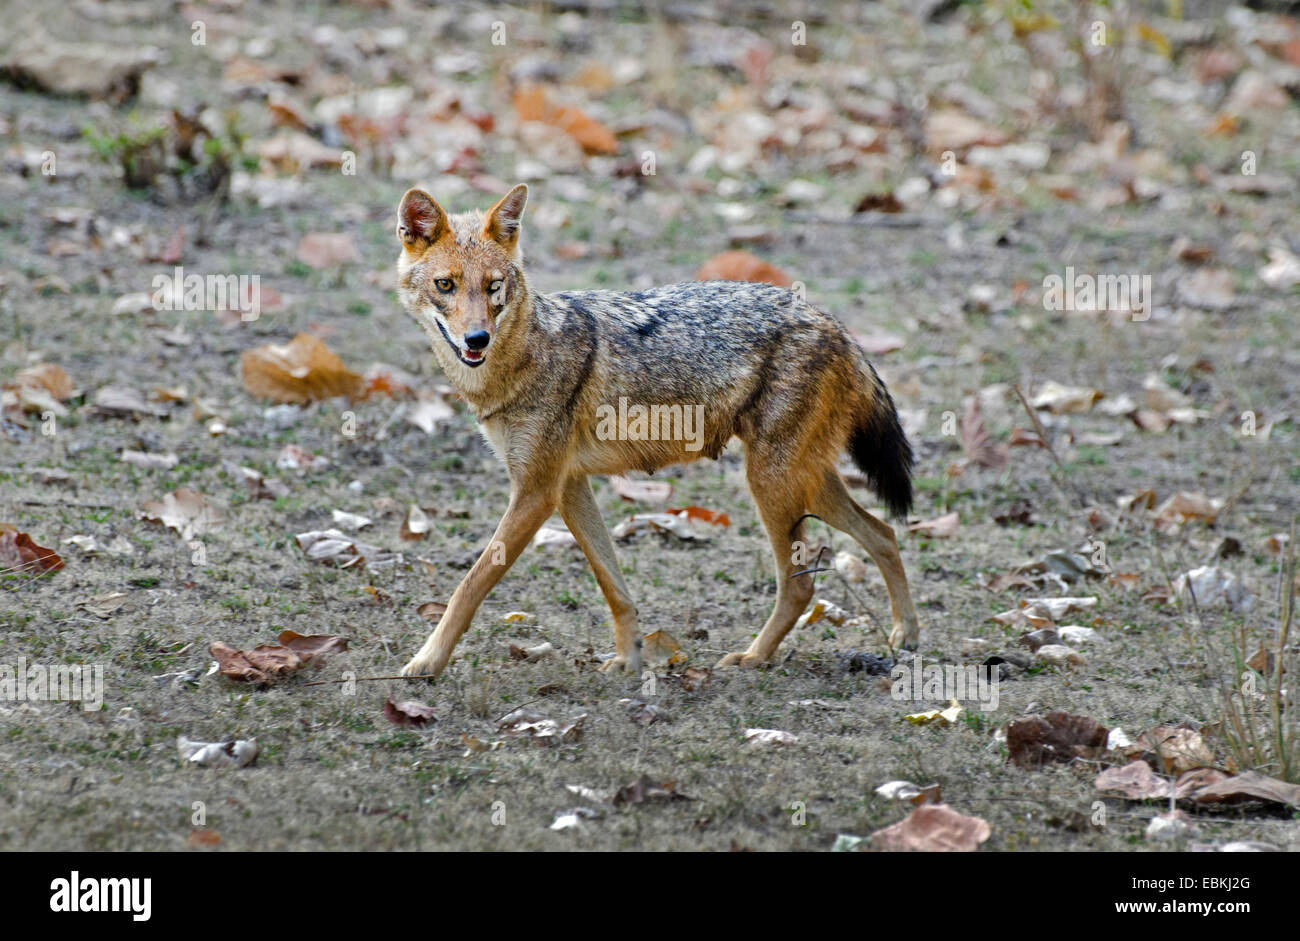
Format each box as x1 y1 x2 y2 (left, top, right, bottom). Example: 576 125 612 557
0 0 1300 850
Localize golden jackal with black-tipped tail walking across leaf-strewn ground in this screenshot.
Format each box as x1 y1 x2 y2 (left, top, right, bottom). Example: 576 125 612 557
398 186 919 676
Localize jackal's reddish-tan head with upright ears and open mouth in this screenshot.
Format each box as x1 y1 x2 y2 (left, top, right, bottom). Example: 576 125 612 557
398 183 528 382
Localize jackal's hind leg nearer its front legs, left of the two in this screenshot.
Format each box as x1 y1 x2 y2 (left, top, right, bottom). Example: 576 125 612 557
718 454 813 667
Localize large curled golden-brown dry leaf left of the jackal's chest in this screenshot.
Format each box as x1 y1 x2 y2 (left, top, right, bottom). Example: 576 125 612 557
239 333 364 404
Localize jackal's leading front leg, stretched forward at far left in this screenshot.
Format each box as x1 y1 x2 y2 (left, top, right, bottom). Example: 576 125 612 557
402 490 555 676
